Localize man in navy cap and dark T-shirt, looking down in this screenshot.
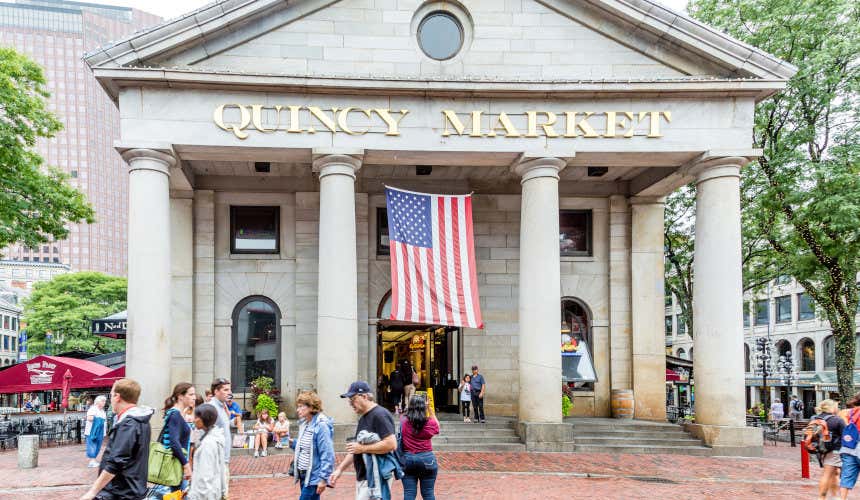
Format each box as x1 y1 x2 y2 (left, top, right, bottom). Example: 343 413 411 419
329 380 400 500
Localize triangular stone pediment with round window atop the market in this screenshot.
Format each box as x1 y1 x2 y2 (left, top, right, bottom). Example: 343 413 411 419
87 0 794 82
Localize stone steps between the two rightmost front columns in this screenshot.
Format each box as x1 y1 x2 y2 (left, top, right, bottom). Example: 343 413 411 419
565 418 712 456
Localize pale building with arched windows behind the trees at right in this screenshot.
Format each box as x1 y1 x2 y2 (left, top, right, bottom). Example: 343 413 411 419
666 276 860 417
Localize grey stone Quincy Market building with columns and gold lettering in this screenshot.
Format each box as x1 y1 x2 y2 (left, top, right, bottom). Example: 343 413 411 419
86 0 795 453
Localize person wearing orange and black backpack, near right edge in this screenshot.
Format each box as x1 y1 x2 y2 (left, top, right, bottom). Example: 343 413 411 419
802 399 845 500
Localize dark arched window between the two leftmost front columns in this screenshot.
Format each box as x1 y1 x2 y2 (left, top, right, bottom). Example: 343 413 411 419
231 296 281 392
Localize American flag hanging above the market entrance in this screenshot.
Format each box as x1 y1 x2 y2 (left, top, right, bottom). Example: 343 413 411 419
385 188 484 328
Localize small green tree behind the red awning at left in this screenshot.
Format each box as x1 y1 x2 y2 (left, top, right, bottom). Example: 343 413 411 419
22 272 128 356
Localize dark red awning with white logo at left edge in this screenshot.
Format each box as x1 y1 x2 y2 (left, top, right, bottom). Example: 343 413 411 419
0 355 115 394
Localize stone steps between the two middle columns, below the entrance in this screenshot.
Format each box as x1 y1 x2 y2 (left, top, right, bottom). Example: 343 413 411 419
433 414 526 452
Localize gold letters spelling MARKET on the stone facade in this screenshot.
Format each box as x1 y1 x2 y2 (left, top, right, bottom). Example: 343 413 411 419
442 109 672 139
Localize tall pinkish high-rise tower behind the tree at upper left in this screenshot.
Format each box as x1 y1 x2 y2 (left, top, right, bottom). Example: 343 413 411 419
0 0 161 275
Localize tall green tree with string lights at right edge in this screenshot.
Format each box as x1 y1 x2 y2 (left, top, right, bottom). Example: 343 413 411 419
690 0 860 400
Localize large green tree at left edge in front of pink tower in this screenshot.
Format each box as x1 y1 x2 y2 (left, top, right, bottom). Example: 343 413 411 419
0 47 95 248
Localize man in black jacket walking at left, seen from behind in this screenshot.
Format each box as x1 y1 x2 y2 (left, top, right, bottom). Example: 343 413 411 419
81 378 153 500
